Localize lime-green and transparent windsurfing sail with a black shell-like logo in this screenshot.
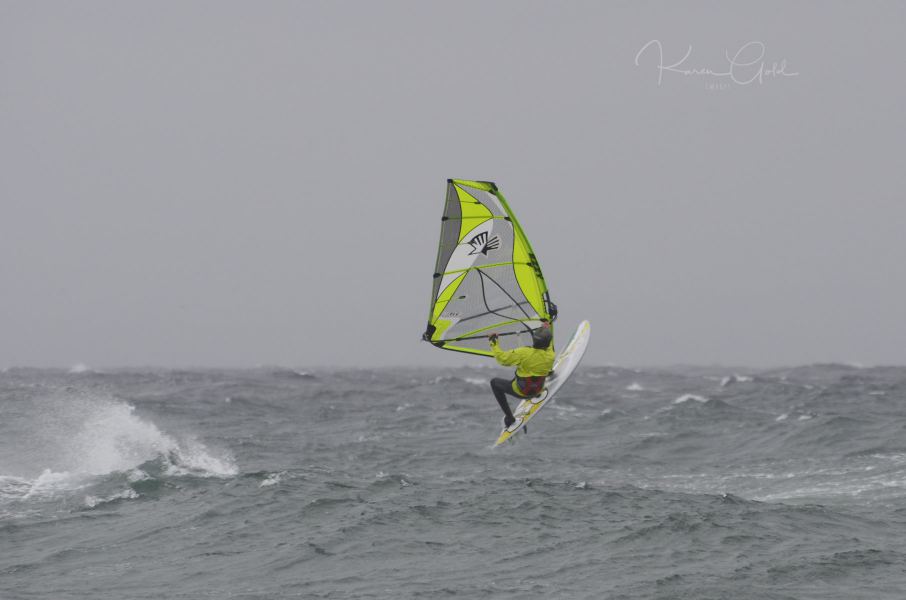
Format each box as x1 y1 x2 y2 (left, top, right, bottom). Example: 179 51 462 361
423 179 556 356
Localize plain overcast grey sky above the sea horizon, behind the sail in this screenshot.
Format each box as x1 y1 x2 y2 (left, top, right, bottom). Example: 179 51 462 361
0 0 906 368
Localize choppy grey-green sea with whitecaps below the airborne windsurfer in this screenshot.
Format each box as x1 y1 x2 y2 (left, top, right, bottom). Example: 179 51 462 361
0 365 906 600
